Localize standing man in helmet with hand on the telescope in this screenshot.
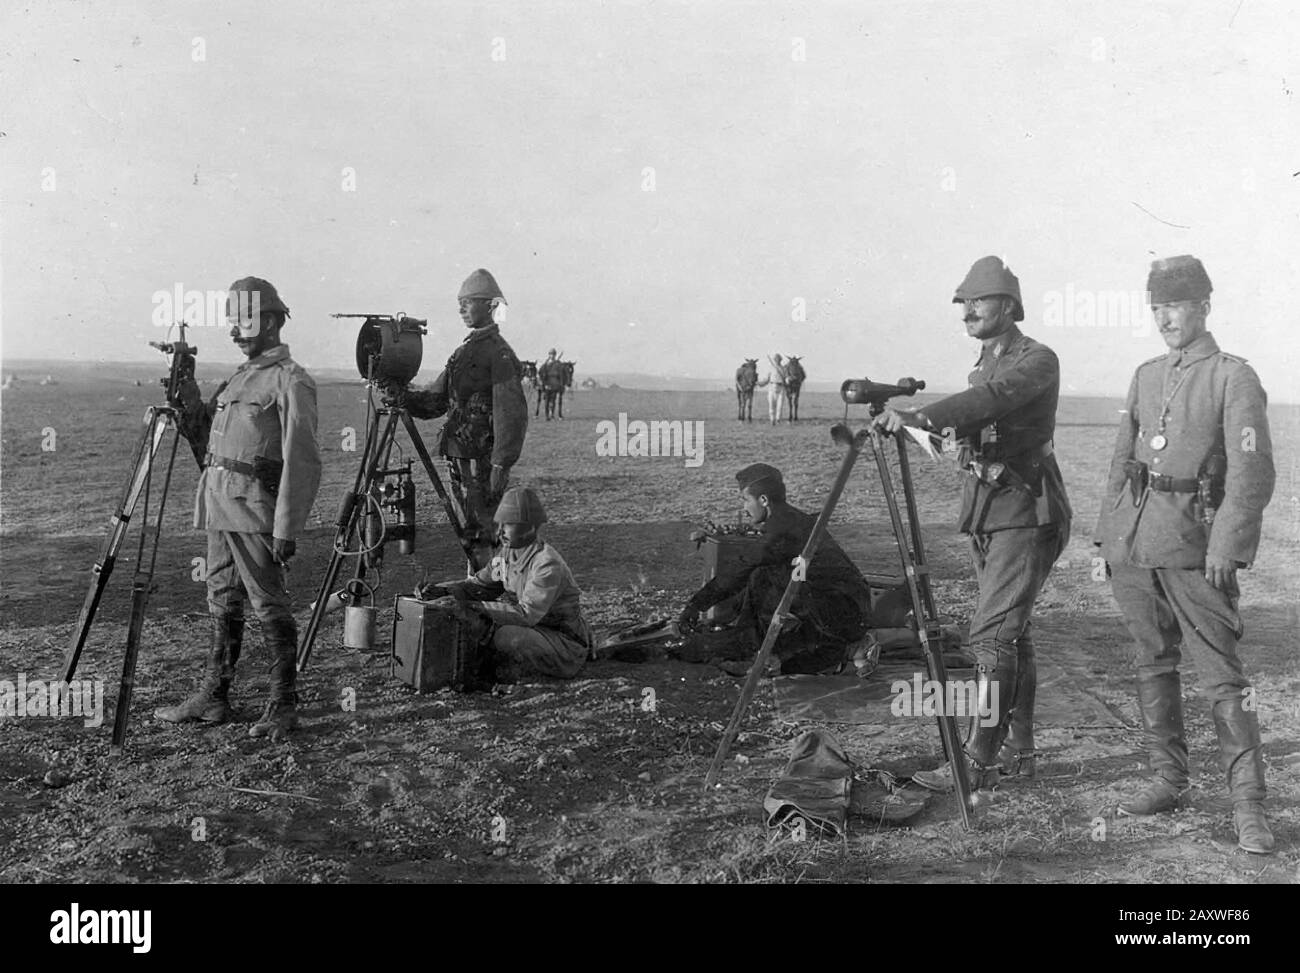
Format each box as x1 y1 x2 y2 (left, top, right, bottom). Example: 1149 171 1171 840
876 256 1071 790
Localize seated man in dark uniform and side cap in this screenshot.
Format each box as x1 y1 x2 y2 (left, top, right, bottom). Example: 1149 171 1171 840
679 463 871 674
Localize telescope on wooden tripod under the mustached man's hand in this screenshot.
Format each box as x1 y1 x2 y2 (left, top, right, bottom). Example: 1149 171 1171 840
705 379 971 829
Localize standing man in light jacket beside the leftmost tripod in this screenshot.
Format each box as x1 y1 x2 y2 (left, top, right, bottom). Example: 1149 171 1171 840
155 277 321 739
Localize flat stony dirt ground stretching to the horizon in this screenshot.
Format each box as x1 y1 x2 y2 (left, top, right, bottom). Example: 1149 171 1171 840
0 362 1300 885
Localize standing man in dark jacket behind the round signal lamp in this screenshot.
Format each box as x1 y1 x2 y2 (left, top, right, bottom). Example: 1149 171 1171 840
404 269 528 568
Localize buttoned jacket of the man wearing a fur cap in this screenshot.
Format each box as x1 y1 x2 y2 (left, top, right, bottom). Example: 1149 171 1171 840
1093 332 1275 568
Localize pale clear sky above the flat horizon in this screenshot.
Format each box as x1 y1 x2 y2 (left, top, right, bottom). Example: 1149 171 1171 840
0 0 1300 402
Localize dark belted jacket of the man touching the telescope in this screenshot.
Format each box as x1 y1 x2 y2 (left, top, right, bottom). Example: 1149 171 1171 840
920 330 1071 533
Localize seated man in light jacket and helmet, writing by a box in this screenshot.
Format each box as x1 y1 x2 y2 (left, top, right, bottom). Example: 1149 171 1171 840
419 487 592 683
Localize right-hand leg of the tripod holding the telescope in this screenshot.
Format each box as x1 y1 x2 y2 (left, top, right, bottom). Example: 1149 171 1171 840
871 427 971 830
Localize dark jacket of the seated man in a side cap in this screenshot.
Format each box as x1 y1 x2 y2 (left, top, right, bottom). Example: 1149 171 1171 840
690 503 871 617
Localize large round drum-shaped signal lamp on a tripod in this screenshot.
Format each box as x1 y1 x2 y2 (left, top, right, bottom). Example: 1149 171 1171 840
298 312 484 673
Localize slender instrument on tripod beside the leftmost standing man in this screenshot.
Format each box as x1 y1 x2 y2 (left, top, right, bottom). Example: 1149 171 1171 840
62 321 202 749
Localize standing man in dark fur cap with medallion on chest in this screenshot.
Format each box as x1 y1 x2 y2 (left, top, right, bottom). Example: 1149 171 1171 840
1096 256 1274 855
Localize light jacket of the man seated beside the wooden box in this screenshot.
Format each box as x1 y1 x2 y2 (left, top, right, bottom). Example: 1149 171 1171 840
468 540 592 646
